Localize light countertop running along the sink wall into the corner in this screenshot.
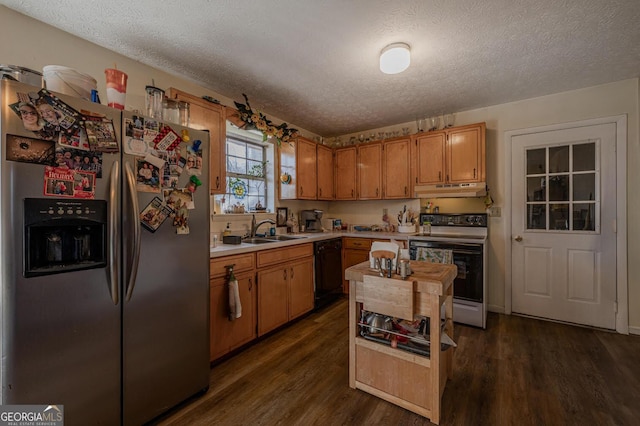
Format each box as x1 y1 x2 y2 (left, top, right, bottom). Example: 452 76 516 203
209 231 417 258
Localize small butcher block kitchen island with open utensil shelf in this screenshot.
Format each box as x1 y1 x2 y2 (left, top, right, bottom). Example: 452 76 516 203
345 261 458 424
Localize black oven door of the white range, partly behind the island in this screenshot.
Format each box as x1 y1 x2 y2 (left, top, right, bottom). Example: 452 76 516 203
409 240 483 303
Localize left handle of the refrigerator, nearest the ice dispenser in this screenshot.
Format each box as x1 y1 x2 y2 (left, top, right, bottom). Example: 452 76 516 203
109 161 120 305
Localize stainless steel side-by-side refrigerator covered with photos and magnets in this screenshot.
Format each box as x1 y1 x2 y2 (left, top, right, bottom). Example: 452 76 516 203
0 80 209 425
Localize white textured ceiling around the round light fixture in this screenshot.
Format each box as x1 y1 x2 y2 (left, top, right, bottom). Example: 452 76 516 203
0 0 640 136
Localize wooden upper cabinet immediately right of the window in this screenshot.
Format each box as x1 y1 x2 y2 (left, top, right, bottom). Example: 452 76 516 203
278 137 318 200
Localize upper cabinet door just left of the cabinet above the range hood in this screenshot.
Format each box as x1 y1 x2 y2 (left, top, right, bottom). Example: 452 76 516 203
382 138 411 199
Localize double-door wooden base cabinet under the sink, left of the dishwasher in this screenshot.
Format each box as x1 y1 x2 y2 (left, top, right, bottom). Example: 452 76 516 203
256 243 314 336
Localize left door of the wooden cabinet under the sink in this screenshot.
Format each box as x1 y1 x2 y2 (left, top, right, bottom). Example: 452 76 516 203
258 266 290 336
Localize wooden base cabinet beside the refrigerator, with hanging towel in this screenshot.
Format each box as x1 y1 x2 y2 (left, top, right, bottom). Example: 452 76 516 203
209 253 257 361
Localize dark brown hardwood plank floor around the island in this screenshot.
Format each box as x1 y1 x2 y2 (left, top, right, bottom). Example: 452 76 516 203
154 299 640 426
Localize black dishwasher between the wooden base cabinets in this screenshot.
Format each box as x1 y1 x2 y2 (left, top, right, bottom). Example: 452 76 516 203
313 238 342 309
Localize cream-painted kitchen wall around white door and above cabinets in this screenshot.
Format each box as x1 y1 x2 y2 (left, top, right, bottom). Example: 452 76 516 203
0 6 640 334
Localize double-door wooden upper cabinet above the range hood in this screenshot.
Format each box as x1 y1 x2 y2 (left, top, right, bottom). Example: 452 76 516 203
414 123 486 190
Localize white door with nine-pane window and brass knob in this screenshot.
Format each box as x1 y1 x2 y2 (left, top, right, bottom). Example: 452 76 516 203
511 123 616 329
